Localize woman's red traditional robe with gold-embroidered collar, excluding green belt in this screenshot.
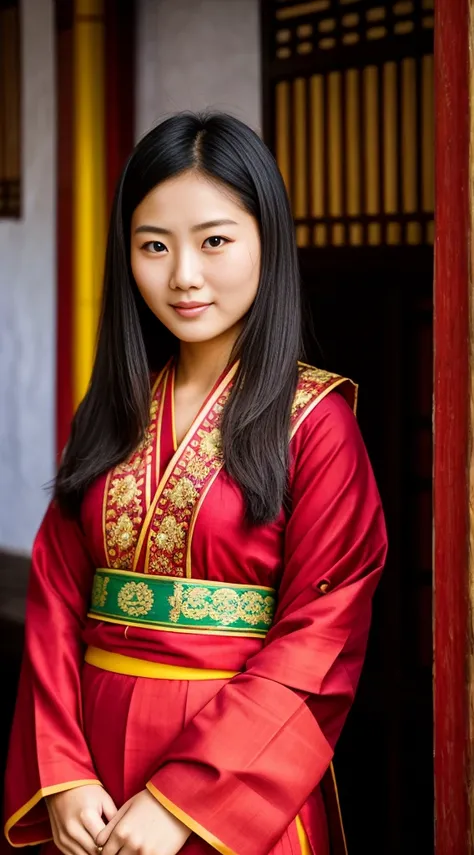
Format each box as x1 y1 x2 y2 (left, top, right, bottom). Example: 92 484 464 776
6 365 386 855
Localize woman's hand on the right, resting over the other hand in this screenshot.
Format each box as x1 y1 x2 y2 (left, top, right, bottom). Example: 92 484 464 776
96 790 191 855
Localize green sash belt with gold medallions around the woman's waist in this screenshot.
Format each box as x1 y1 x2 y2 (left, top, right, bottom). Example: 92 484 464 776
89 568 275 637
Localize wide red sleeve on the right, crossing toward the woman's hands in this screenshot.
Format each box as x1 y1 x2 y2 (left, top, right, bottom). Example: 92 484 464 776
147 392 386 855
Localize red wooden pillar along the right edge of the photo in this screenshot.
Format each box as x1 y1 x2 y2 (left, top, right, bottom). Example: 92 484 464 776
434 0 474 855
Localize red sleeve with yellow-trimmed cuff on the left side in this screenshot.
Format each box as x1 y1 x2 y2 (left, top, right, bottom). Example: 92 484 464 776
5 504 99 846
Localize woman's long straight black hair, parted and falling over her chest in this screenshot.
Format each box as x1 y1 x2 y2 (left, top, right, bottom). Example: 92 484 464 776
55 113 301 524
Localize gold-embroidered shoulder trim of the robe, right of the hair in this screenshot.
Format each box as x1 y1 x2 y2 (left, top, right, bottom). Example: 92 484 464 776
291 362 357 436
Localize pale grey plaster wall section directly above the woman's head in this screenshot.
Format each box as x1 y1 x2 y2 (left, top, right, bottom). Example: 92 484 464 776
136 0 261 138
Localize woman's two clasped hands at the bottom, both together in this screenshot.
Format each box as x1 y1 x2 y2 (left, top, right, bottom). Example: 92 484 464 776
46 784 191 855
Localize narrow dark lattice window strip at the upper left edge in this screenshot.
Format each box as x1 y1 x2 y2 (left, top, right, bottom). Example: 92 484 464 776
0 0 21 217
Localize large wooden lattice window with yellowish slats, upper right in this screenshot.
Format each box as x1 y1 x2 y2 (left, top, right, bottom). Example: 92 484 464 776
265 0 434 247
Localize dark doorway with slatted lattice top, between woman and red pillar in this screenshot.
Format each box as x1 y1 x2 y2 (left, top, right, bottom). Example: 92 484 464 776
262 0 434 855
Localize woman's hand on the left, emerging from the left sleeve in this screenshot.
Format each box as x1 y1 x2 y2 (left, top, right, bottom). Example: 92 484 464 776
45 784 117 855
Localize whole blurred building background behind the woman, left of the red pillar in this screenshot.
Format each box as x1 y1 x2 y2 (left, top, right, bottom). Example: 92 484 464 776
0 0 434 855
